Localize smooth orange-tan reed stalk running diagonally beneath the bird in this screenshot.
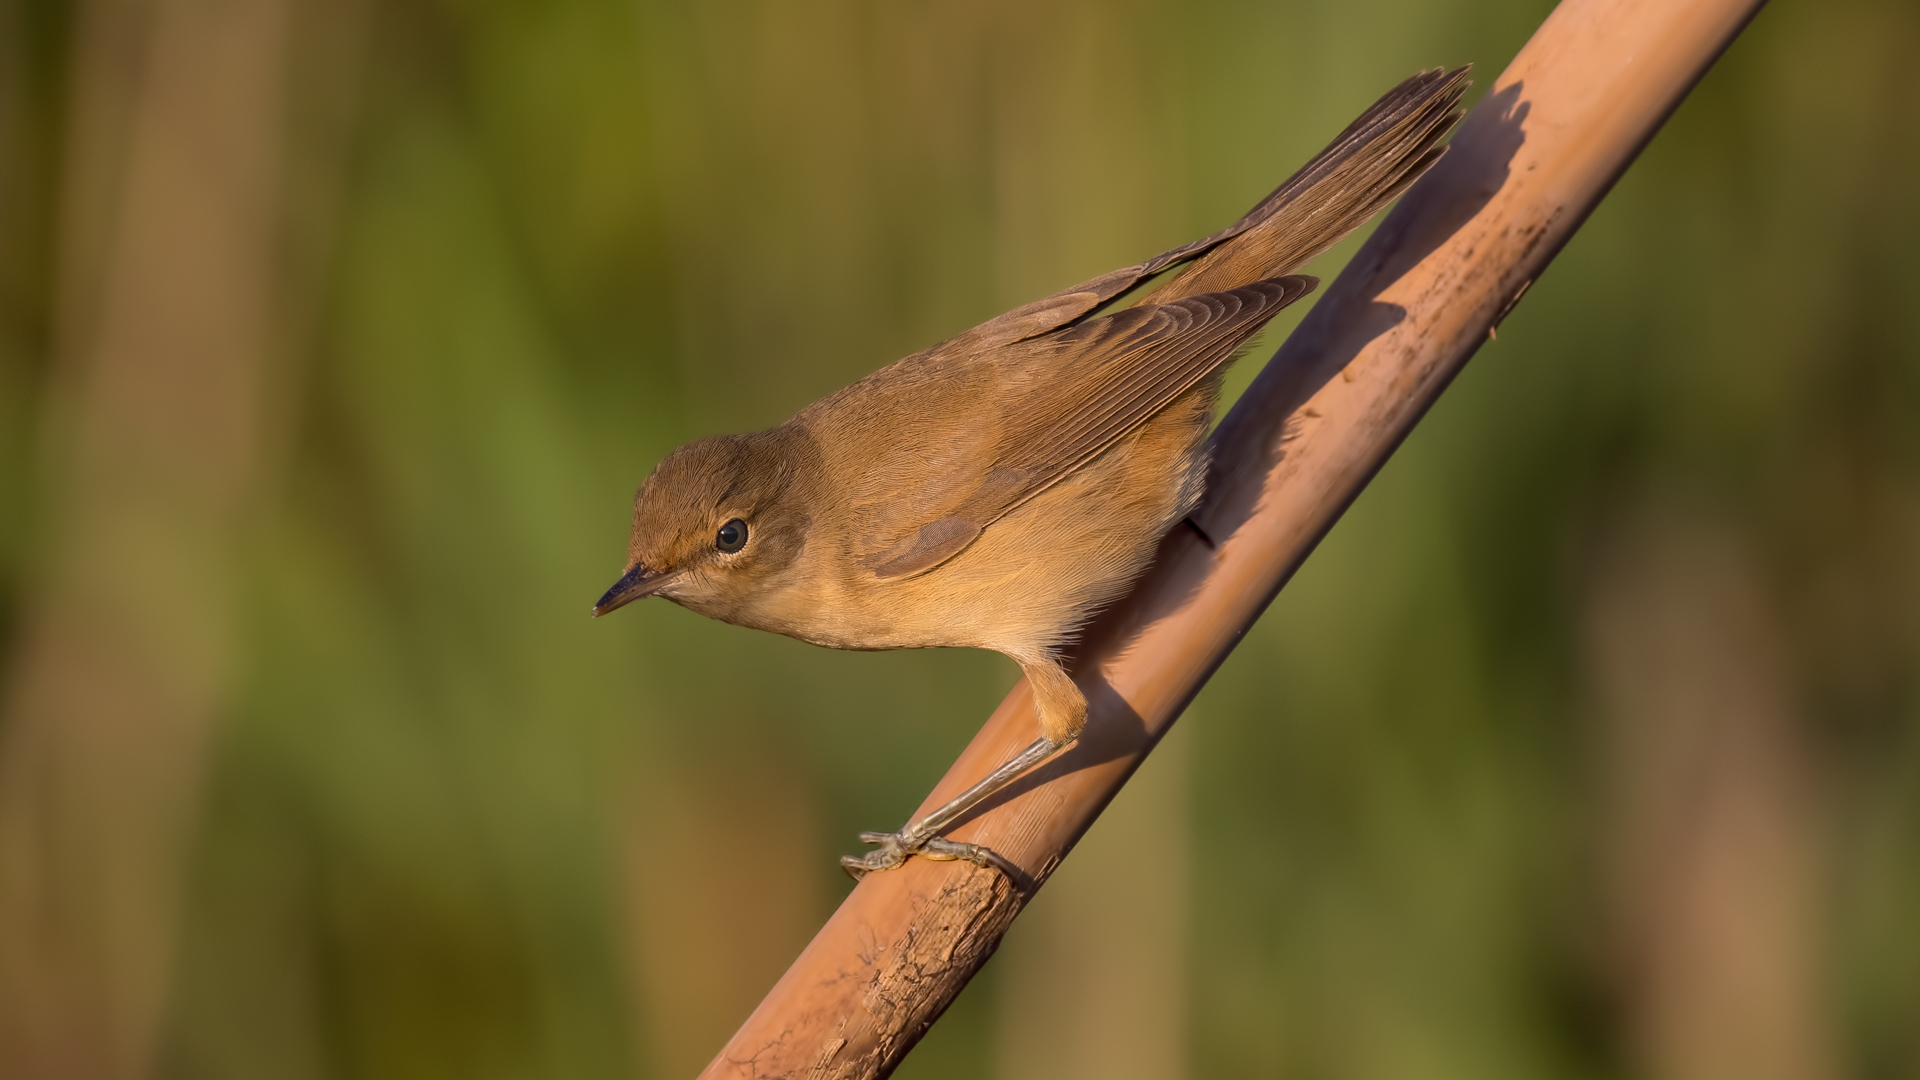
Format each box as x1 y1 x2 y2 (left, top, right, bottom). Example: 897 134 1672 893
703 0 1763 1080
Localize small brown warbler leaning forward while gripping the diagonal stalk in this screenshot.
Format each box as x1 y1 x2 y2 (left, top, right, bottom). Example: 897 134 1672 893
593 67 1467 876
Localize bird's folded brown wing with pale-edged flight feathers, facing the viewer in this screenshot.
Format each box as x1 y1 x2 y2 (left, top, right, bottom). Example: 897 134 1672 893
849 277 1315 578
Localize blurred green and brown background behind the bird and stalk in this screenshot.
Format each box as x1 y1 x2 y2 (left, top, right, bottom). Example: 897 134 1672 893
0 0 1920 1080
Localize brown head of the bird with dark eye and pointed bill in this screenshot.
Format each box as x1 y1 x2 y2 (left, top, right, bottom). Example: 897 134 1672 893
593 429 810 621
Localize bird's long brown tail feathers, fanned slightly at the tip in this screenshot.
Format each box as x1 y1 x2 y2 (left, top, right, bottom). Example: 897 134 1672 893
1146 67 1469 304
